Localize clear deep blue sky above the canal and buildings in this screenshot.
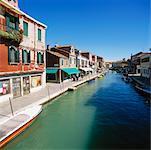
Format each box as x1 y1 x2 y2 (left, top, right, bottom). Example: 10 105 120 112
19 0 150 60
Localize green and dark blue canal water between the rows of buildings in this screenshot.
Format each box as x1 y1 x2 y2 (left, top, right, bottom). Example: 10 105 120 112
4 72 150 150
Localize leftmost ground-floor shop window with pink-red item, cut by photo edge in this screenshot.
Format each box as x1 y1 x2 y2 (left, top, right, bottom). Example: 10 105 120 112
0 80 10 96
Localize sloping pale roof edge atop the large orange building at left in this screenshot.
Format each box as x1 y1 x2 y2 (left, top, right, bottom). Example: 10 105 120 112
0 0 47 28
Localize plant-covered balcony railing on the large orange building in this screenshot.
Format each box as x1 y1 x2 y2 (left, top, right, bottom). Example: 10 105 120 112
0 24 23 44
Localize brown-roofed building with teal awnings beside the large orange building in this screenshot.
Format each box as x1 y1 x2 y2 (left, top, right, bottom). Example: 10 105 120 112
46 46 80 82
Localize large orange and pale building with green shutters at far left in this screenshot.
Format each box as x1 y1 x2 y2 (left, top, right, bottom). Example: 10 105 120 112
0 0 46 102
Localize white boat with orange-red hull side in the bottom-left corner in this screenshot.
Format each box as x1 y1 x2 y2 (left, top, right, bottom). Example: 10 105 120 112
0 105 42 148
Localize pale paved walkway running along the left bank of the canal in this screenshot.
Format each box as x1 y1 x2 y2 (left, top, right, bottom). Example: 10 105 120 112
0 74 97 121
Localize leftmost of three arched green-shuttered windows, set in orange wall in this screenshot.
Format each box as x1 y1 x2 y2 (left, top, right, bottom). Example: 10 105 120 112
8 46 19 63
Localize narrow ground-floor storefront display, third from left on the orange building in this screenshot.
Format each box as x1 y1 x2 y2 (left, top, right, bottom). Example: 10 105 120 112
23 77 30 95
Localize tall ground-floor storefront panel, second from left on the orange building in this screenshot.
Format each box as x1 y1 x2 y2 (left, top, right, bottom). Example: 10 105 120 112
13 78 21 98
